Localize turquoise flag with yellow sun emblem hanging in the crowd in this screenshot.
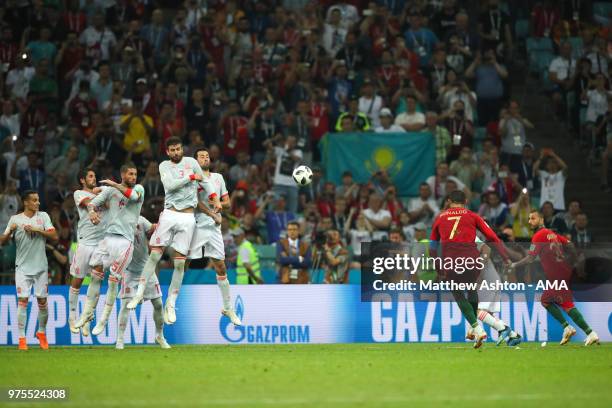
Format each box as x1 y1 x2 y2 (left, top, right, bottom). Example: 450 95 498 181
320 132 435 196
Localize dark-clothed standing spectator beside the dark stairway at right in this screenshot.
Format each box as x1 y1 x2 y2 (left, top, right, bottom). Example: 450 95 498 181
499 101 534 168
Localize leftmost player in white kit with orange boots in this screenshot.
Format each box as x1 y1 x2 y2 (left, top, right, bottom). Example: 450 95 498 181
0 190 58 350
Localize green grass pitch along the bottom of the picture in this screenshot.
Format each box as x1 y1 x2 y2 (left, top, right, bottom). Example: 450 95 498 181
0 343 612 408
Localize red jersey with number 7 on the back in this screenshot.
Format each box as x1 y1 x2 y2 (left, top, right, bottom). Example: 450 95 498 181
430 207 508 259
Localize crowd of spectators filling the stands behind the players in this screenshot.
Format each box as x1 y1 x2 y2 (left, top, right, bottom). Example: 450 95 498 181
0 0 612 283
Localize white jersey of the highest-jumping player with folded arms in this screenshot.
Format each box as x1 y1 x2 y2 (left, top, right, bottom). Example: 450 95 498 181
159 157 204 211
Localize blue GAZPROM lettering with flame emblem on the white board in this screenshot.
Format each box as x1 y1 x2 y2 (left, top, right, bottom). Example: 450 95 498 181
219 296 310 343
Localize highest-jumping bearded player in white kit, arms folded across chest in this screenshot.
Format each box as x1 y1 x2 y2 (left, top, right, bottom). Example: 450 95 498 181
127 137 221 324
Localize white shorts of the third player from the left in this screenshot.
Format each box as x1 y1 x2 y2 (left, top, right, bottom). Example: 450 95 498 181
89 235 134 279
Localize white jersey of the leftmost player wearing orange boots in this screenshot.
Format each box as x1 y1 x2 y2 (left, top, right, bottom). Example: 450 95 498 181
4 211 55 275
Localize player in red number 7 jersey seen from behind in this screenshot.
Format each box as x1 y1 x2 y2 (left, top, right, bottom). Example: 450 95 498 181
430 190 508 348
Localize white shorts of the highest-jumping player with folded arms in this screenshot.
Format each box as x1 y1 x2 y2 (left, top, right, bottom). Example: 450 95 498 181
149 209 195 255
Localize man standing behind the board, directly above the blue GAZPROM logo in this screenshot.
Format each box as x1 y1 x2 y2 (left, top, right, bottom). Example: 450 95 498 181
276 221 312 284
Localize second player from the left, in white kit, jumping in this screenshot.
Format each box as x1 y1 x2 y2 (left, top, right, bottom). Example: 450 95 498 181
68 168 106 336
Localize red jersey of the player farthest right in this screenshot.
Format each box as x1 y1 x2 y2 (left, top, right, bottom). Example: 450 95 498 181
529 228 572 280
